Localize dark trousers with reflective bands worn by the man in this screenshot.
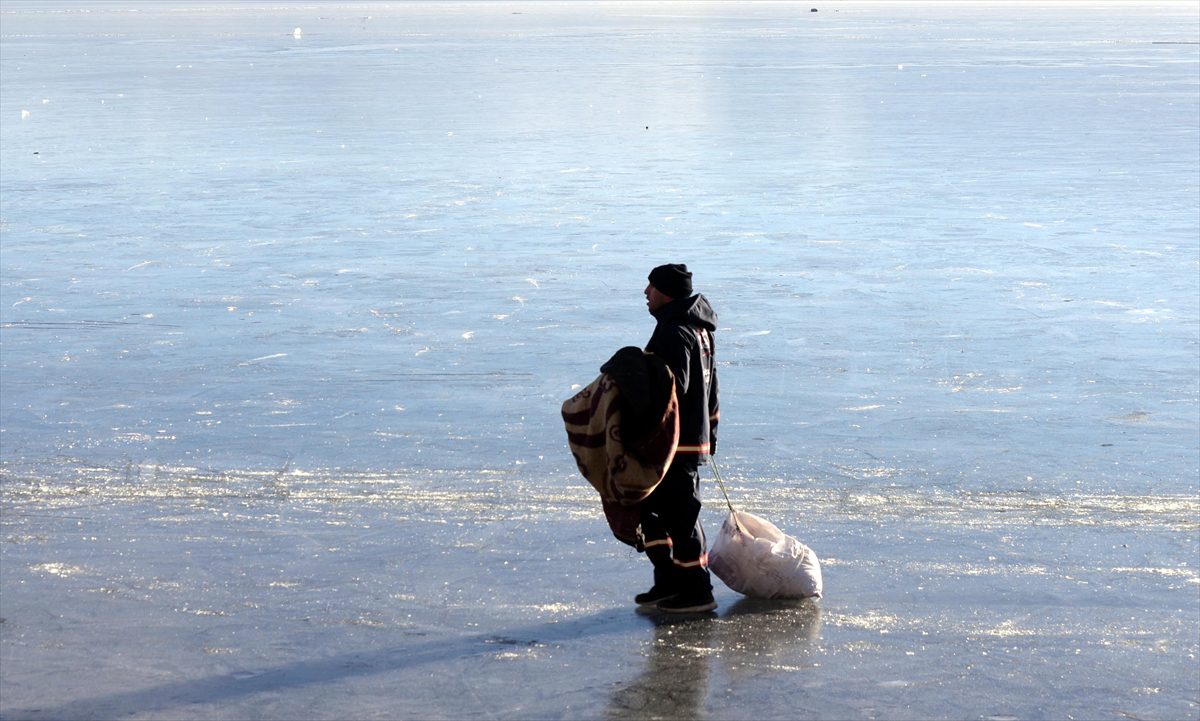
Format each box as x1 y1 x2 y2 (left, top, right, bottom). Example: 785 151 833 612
638 458 713 591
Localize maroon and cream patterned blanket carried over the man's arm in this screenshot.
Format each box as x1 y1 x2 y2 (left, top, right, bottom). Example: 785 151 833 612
563 373 679 508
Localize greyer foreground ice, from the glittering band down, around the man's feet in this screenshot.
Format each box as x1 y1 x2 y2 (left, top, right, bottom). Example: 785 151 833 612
0 470 1198 719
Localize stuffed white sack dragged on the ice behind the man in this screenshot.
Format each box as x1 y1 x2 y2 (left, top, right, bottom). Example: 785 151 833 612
708 511 821 599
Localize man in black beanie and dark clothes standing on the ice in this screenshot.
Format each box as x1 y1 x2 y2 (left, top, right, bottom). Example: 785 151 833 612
635 264 720 613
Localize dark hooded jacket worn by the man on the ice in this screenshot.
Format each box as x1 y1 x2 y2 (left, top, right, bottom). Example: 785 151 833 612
646 295 721 463
